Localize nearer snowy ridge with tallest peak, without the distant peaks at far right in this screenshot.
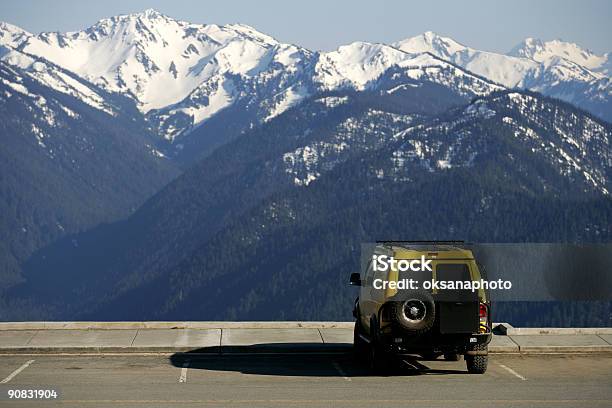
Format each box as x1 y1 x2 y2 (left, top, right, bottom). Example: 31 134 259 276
0 10 502 147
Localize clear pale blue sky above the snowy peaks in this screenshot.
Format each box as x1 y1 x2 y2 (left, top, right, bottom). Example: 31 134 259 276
0 0 612 53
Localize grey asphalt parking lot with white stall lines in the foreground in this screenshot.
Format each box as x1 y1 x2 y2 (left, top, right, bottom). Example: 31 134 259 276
0 353 612 407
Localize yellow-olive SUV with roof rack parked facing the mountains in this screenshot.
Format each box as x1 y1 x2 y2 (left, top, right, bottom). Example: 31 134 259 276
350 241 491 374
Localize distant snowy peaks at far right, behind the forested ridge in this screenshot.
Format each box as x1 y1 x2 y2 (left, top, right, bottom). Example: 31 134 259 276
394 31 612 121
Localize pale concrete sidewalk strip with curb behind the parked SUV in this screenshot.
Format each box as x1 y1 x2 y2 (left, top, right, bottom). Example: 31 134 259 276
0 322 612 355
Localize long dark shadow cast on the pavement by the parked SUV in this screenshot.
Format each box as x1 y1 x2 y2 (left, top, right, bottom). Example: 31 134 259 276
169 343 468 378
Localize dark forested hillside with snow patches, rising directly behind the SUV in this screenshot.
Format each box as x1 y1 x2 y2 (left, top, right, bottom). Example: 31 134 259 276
7 92 612 324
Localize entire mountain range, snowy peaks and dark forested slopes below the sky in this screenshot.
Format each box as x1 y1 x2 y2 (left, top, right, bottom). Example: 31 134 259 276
0 10 612 320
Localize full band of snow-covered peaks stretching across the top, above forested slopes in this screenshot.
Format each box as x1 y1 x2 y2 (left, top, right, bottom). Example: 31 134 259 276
0 10 612 150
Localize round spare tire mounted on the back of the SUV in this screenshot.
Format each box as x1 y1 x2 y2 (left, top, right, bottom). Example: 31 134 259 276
391 290 436 334
